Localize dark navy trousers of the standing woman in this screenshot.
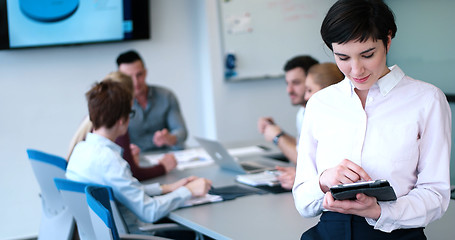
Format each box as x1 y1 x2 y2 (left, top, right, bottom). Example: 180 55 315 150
300 212 427 240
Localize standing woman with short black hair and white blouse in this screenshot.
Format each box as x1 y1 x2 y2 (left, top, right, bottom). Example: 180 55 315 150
293 0 451 239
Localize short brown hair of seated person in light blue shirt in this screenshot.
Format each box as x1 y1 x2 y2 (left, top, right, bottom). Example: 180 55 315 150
85 79 133 130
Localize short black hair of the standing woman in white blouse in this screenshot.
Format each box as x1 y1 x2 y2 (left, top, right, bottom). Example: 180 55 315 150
321 0 397 50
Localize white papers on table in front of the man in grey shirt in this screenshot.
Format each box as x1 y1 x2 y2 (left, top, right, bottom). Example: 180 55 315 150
143 148 213 170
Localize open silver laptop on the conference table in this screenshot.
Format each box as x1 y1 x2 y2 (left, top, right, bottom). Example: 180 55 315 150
195 137 276 174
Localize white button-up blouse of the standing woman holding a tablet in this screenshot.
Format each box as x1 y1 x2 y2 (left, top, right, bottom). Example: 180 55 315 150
293 66 451 232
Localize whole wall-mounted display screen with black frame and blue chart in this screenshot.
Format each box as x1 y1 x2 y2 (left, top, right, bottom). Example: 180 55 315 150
0 0 150 49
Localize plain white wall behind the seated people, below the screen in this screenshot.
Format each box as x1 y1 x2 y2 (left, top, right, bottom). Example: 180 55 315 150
0 0 296 239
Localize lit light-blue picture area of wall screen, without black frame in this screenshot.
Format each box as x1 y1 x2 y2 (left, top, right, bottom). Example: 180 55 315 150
6 0 124 48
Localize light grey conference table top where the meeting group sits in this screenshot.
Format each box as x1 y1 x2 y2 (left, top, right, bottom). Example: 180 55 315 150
144 142 455 239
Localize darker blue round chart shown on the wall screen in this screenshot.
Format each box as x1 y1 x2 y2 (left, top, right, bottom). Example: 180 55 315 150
19 0 79 22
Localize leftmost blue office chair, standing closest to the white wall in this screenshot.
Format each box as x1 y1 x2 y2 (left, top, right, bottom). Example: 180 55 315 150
27 149 74 240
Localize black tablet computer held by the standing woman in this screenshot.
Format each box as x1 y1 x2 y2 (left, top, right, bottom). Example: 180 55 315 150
330 179 397 201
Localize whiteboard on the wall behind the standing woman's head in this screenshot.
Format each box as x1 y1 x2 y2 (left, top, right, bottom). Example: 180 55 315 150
219 0 335 81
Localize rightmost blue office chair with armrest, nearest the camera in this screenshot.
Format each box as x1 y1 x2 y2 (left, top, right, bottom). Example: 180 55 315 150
85 185 173 240
